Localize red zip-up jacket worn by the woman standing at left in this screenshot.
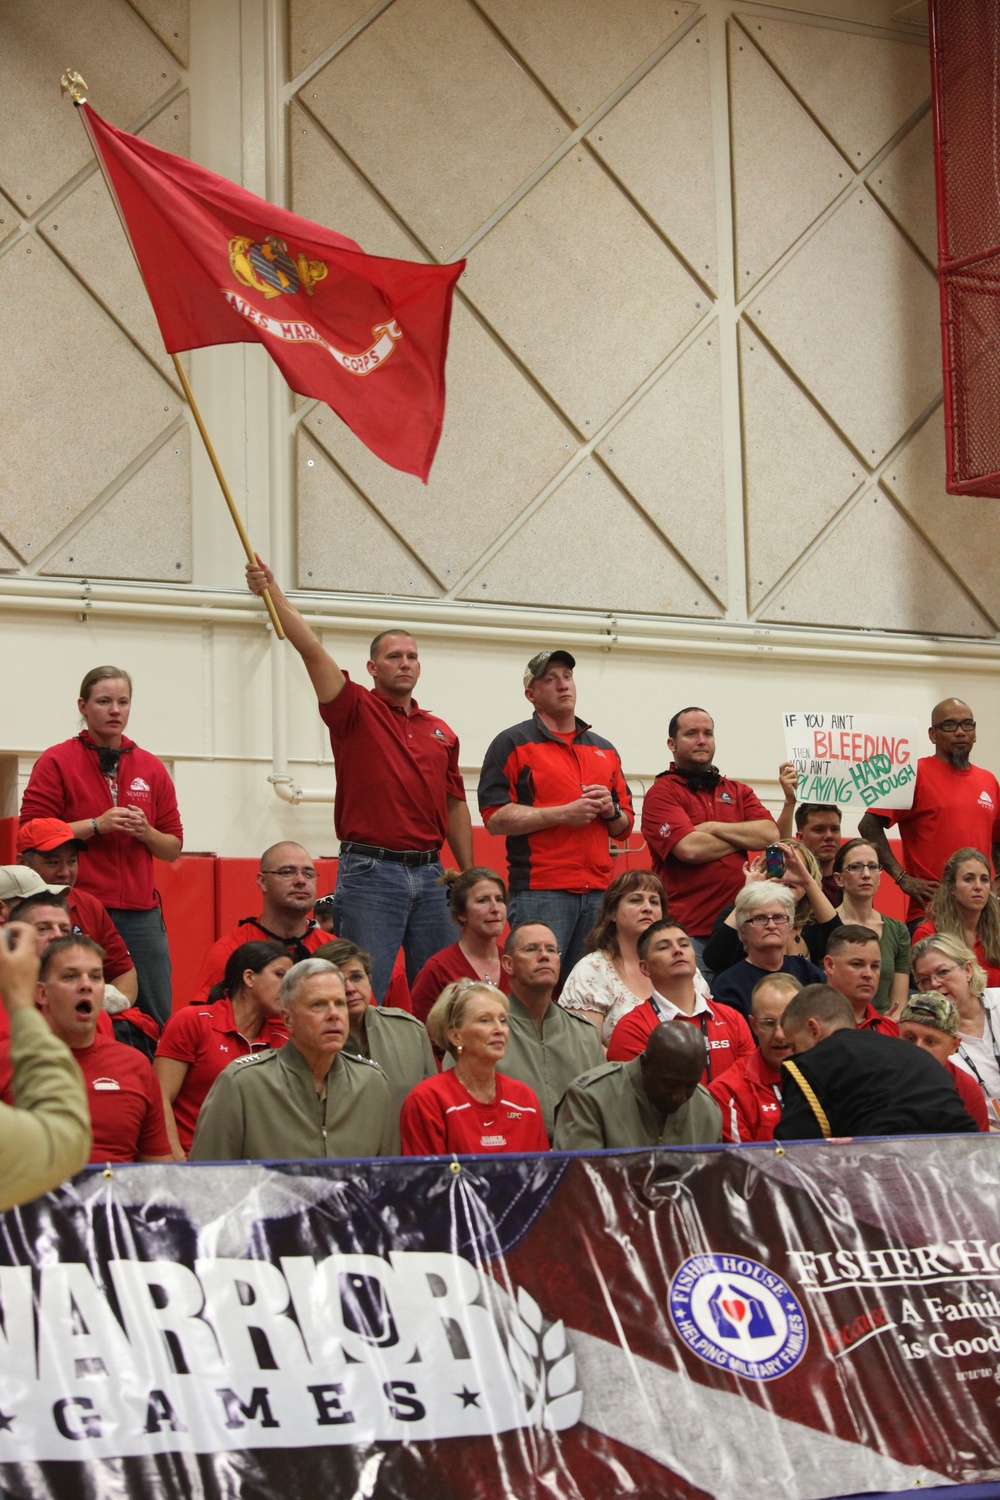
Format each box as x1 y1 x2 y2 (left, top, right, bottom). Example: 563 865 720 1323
21 735 184 912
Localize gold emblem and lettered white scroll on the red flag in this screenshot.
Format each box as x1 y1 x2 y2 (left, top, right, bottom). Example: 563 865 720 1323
222 234 403 375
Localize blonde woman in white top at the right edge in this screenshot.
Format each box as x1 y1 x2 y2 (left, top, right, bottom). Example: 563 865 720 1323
910 933 1000 1131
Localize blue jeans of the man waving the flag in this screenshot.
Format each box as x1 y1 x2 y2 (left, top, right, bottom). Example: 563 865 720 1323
333 852 459 1005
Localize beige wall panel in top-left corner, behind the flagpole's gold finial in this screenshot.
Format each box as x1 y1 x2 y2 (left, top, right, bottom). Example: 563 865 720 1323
0 0 178 213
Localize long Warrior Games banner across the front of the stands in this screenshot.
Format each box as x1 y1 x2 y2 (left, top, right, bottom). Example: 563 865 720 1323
0 1137 1000 1500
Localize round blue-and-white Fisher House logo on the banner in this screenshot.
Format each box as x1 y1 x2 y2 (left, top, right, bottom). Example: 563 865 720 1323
667 1256 807 1380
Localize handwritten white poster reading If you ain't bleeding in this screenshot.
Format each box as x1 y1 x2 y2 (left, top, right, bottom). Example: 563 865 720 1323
784 713 918 810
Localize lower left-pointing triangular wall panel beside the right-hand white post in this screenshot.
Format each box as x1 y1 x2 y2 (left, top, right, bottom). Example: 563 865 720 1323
597 323 727 603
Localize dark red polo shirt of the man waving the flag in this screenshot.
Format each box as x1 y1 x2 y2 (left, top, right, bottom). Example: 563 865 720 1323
319 672 465 849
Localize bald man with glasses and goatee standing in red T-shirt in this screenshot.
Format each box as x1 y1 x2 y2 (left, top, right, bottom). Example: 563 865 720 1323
858 698 1000 932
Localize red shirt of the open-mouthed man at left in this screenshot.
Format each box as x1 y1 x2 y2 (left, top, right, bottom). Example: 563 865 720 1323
73 1037 171 1163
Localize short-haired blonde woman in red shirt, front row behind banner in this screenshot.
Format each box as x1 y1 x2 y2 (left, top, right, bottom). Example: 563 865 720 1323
399 980 549 1157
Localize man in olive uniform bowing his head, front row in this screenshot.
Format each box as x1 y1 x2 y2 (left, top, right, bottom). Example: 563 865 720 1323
552 1020 723 1151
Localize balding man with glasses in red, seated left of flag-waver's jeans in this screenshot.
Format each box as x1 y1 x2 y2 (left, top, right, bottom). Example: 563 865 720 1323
190 843 330 1004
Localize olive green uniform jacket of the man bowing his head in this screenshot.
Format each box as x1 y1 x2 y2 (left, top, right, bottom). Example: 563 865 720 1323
552 1062 723 1151
